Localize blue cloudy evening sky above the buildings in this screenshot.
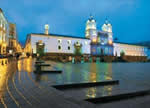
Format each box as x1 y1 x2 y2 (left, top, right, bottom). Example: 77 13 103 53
0 0 150 43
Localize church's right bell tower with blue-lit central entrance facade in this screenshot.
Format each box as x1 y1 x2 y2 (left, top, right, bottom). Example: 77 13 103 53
91 17 113 56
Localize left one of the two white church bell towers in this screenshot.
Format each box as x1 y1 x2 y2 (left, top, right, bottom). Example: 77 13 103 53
85 15 97 42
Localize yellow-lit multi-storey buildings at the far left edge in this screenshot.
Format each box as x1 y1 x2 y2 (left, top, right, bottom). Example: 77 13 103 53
0 8 22 55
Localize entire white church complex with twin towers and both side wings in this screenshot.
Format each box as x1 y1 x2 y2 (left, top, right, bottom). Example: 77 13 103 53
25 16 148 60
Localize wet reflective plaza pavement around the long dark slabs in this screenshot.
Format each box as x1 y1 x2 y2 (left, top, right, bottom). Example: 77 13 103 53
0 58 150 108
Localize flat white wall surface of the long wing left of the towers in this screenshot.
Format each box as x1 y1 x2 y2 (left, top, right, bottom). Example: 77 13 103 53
31 34 90 54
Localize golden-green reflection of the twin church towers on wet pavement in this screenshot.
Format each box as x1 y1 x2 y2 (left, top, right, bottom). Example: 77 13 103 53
86 63 112 98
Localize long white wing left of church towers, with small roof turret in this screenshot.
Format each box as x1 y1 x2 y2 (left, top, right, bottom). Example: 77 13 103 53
25 25 91 55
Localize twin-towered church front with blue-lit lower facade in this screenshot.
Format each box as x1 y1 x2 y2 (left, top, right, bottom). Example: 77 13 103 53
85 17 113 56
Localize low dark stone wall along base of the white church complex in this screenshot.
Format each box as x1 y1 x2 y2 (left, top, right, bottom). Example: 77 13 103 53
39 54 147 62
